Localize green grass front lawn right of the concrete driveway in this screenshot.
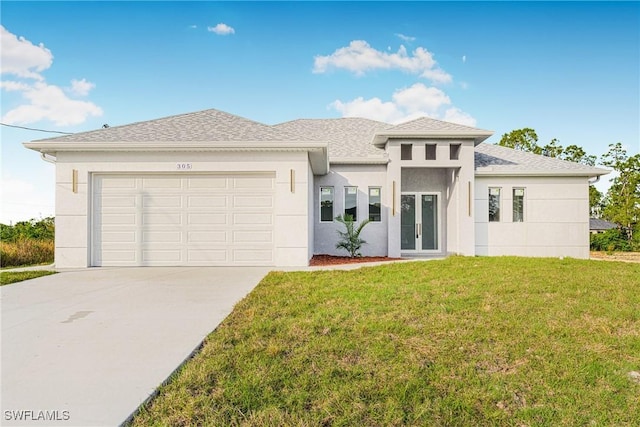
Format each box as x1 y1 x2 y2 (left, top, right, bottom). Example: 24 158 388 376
133 257 640 426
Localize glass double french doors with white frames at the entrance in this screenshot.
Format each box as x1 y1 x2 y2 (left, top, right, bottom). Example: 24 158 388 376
400 193 440 252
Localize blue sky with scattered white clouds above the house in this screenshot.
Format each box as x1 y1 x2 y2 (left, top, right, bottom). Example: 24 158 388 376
0 1 640 223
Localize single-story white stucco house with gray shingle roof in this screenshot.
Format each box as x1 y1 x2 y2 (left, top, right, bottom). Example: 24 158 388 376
25 110 608 268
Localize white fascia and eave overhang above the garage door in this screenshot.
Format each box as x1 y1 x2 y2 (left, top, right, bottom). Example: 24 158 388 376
23 141 329 175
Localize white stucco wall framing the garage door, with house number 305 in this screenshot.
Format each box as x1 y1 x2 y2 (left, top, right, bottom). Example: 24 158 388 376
55 152 312 268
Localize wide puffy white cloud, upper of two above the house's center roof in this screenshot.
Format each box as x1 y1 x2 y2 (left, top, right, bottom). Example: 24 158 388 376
313 40 452 83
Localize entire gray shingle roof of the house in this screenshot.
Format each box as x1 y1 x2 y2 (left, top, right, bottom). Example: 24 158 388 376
28 109 608 175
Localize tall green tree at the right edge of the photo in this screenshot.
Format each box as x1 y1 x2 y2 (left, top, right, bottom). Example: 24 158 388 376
600 142 640 242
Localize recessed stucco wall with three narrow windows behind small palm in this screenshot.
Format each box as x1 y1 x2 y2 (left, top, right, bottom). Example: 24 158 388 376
313 165 391 256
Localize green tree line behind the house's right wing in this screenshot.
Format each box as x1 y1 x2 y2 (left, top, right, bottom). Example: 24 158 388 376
498 128 640 250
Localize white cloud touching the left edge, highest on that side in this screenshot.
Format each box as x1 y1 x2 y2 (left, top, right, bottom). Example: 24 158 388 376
0 25 53 80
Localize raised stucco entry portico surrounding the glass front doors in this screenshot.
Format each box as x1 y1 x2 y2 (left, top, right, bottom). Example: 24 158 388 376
387 139 475 257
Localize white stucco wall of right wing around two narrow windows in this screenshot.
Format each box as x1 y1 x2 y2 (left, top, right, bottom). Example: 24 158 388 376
475 176 589 258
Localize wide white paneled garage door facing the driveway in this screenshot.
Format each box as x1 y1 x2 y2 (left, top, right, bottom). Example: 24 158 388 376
92 174 274 266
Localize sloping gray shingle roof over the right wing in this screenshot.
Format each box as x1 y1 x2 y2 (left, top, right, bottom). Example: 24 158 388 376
475 144 609 176
